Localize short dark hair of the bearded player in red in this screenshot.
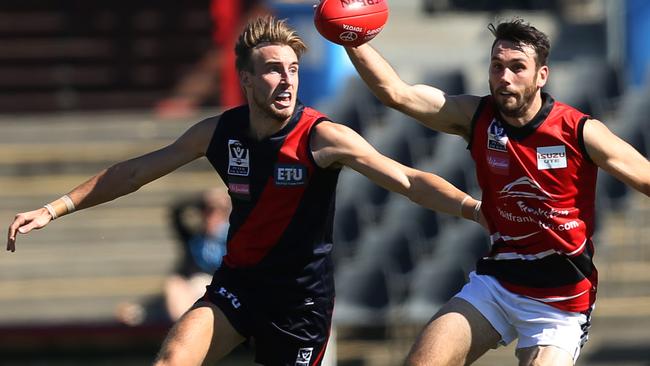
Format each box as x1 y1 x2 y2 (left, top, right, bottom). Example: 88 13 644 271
488 18 551 67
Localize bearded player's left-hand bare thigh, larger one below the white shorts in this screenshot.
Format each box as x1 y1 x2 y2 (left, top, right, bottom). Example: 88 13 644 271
406 297 501 365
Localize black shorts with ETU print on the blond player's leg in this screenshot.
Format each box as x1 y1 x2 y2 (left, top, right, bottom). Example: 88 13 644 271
203 277 334 366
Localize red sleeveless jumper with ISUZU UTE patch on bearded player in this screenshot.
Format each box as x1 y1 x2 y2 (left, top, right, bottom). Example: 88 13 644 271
468 93 598 312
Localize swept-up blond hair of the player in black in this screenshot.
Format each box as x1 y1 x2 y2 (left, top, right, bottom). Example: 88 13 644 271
235 15 307 71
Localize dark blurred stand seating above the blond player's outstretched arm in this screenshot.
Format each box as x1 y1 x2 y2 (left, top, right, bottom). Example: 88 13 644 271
0 0 212 113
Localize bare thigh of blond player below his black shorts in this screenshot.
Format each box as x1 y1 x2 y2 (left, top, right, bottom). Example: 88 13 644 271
155 302 244 366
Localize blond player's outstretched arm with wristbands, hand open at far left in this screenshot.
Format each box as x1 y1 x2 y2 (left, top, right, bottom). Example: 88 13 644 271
7 119 214 252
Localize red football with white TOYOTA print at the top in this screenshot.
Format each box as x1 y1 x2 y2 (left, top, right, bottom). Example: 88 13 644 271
314 0 388 47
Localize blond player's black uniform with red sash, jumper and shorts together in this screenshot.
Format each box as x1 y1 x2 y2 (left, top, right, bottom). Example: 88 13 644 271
197 103 340 366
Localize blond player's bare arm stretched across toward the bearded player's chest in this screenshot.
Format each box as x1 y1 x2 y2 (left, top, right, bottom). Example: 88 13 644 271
311 122 480 221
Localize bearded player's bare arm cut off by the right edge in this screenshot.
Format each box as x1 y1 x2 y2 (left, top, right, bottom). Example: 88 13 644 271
583 119 650 196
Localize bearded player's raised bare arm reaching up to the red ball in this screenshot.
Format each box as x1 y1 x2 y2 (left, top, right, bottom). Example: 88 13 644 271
346 44 480 140
